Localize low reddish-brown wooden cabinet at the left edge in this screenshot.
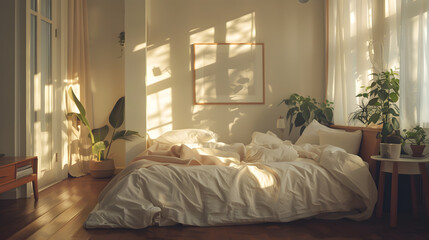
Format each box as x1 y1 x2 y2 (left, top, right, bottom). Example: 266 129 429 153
0 157 39 200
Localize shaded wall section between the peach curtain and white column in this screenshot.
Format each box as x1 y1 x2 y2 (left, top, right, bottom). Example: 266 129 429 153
88 0 125 167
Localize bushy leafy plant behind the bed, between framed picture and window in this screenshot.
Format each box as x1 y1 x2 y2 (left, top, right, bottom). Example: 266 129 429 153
280 93 334 134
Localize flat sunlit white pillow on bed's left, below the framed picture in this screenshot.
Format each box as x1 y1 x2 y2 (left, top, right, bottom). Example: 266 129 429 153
153 129 217 144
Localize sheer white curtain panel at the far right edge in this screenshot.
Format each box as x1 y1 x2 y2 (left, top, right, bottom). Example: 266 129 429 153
400 0 429 128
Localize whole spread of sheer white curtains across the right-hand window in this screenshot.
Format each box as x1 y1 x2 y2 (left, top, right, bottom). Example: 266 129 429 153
327 0 429 128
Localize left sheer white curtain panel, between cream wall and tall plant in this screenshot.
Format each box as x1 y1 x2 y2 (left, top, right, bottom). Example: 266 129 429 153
327 0 376 124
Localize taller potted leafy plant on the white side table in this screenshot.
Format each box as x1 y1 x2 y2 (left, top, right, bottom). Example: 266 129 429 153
350 69 402 158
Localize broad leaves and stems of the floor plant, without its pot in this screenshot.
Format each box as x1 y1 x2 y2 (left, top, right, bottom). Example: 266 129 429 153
68 88 139 161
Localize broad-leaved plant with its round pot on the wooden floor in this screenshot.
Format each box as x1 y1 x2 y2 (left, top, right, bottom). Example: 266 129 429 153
67 88 139 178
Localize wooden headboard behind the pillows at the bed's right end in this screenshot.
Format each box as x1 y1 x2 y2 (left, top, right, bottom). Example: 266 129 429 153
330 125 381 180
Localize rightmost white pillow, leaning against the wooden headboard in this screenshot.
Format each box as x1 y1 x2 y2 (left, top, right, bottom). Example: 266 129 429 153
319 130 362 155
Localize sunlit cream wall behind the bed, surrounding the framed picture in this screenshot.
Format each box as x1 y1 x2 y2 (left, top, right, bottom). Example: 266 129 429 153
147 0 325 143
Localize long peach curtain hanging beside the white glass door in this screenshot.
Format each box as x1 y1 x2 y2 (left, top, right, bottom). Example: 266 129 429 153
67 0 93 177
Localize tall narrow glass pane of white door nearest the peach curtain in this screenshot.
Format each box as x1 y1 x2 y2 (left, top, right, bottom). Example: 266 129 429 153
40 20 53 170
